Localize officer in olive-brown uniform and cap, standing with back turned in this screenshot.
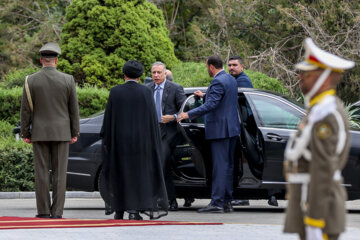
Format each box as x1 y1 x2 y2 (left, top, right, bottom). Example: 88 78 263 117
20 43 79 218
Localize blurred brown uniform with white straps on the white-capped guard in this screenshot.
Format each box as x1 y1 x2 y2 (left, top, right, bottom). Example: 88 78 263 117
284 93 350 239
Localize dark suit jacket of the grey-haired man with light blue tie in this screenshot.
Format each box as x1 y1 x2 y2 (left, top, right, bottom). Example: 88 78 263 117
146 81 186 123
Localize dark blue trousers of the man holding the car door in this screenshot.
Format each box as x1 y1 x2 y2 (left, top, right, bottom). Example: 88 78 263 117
210 137 237 207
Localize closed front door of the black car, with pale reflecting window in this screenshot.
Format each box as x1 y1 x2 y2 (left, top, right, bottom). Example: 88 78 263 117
245 92 305 184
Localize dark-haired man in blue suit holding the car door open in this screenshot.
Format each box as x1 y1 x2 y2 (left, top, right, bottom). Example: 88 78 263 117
178 56 240 213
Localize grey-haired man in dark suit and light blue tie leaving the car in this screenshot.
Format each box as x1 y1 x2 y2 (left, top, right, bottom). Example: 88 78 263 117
147 62 186 211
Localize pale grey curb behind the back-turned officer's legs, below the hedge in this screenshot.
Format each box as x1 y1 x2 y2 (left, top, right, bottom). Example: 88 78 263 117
0 191 101 199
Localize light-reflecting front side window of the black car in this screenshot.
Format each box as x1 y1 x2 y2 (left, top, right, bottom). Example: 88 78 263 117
249 94 303 129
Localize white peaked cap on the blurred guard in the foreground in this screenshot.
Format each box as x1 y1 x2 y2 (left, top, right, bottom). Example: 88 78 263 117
295 38 355 72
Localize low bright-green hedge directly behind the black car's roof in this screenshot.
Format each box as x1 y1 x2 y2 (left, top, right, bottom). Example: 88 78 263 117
171 62 287 94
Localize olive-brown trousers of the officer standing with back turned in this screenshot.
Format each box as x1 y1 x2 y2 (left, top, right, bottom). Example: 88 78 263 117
33 142 69 216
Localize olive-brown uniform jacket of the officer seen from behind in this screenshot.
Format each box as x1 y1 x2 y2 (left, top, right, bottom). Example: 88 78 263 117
20 67 79 142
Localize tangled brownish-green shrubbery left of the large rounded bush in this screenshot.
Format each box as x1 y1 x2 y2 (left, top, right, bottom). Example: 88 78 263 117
0 0 69 78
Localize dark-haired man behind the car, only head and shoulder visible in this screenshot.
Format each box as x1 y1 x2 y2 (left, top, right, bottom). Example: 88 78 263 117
228 56 253 88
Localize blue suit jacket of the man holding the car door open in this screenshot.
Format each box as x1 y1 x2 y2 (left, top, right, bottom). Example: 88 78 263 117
188 71 240 139
